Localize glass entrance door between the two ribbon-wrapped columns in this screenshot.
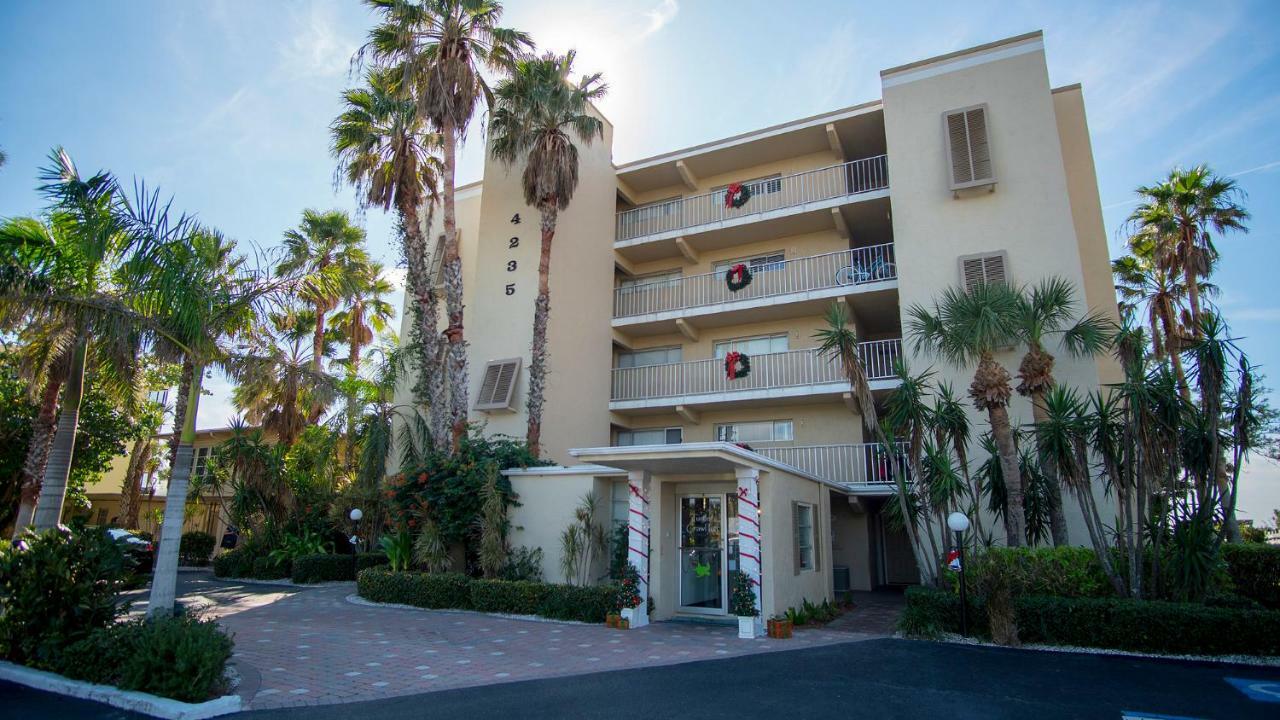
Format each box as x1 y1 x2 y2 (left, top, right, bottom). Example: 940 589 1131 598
678 495 728 615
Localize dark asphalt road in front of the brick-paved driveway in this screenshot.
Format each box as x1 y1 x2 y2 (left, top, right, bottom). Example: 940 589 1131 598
0 639 1280 720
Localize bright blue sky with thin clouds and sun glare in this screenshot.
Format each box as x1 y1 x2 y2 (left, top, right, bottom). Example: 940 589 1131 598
0 0 1280 524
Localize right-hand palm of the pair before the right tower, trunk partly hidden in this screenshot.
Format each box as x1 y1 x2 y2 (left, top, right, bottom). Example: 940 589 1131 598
1015 277 1112 547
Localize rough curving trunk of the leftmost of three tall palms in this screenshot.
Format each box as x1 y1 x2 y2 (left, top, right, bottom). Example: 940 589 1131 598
399 193 453 447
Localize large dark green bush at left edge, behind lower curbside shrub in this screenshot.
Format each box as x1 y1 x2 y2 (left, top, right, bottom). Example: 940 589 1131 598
0 527 131 669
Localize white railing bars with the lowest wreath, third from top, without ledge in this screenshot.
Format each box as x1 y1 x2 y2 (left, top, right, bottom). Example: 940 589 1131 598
609 340 902 401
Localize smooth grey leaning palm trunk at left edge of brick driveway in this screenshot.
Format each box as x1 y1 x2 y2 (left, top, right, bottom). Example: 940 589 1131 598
147 364 204 618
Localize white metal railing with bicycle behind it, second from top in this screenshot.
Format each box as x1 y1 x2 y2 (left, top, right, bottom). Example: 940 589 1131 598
613 242 897 318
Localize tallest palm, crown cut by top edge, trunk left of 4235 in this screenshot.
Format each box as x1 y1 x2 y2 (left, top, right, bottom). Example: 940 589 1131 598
360 0 534 450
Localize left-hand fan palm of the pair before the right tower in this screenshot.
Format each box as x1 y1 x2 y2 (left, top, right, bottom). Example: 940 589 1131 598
908 283 1027 547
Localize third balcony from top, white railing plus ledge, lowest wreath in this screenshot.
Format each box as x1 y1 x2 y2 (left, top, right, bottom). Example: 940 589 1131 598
609 340 902 411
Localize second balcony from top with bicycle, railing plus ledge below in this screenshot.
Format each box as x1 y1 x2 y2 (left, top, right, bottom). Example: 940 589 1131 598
613 242 897 332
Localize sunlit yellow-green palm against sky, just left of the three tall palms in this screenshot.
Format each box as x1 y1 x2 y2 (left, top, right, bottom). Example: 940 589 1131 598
275 210 369 373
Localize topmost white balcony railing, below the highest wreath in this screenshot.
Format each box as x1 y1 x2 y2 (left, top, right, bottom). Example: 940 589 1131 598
614 155 888 240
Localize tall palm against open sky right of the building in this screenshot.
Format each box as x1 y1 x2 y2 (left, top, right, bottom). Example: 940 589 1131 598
1129 165 1249 337
